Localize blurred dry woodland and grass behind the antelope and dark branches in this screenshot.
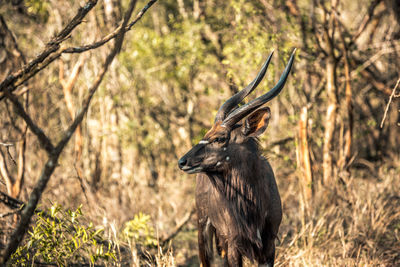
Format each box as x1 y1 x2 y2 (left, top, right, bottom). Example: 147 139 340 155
0 0 400 266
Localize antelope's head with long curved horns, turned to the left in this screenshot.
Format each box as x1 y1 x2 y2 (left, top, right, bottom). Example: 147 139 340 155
178 50 295 176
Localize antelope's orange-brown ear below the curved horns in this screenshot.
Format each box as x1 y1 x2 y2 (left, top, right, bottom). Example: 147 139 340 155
243 107 271 137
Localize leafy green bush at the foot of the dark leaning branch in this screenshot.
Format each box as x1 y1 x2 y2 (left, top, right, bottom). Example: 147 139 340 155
10 204 116 266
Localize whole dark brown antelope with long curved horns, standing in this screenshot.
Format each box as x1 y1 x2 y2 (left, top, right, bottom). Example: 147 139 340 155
178 52 295 267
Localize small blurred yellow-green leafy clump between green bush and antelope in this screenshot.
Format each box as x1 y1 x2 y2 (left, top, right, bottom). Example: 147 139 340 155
123 212 157 247
